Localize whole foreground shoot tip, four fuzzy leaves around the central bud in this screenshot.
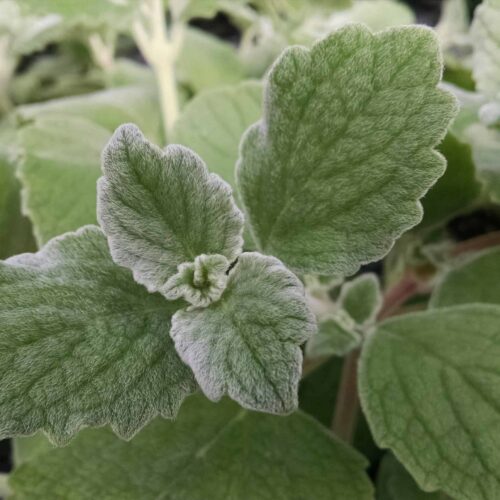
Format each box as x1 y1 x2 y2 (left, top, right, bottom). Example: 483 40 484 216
0 26 455 441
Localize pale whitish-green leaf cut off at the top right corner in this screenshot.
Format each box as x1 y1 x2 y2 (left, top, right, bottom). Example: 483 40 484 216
471 0 500 97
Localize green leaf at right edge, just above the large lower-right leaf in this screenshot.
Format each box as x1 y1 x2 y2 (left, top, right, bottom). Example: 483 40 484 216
430 248 500 307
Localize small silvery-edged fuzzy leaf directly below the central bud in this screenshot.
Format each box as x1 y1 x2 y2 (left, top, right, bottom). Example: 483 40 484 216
170 253 315 413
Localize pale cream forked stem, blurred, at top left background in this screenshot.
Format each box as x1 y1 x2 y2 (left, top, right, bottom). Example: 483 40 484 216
134 0 183 142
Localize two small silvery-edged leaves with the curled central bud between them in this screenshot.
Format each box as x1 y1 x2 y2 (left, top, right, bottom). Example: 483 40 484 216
98 120 315 413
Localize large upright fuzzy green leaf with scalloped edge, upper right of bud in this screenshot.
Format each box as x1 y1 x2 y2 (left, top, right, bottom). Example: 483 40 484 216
237 25 455 275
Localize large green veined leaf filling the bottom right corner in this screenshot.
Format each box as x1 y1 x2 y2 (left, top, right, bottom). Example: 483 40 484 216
360 304 500 500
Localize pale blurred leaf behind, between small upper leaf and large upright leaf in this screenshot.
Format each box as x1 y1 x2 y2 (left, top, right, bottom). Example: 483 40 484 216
173 82 262 186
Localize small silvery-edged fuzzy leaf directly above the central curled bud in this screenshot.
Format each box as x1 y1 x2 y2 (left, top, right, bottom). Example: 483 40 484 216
98 124 243 291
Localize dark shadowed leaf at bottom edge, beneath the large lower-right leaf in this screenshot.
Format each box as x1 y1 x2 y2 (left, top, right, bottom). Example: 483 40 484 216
376 453 449 500
